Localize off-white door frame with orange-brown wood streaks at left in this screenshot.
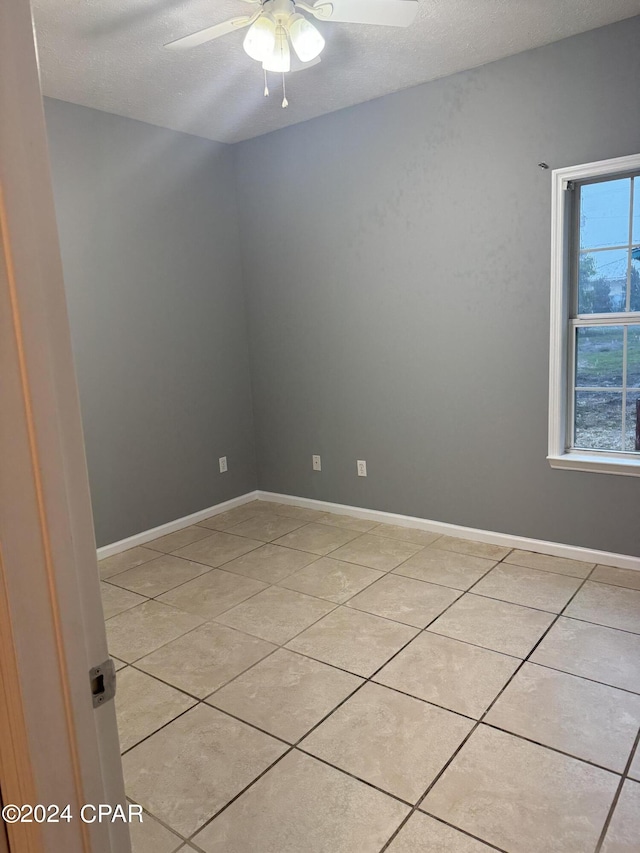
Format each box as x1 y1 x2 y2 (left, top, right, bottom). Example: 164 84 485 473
0 0 130 853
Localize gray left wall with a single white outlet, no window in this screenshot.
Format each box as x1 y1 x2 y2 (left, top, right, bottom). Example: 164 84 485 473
46 100 256 545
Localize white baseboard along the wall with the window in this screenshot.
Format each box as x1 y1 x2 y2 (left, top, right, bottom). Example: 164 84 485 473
255 490 640 571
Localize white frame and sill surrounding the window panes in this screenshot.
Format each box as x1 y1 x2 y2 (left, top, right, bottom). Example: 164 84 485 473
547 154 640 477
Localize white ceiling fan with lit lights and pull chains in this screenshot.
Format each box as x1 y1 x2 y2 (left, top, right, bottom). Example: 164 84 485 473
165 0 418 107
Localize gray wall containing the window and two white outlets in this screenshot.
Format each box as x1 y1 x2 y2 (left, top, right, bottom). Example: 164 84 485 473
237 18 640 555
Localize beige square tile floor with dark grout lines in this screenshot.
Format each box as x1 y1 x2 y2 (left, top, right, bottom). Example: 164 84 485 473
100 501 640 853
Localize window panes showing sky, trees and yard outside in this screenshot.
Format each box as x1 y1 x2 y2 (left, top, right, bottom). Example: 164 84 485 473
571 177 640 453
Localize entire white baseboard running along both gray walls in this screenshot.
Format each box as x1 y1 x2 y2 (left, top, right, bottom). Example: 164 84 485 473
98 490 640 571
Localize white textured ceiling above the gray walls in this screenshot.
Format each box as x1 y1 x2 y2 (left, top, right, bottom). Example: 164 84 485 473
33 0 640 142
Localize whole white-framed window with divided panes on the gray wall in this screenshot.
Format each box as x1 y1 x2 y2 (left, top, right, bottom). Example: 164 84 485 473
548 155 640 476
